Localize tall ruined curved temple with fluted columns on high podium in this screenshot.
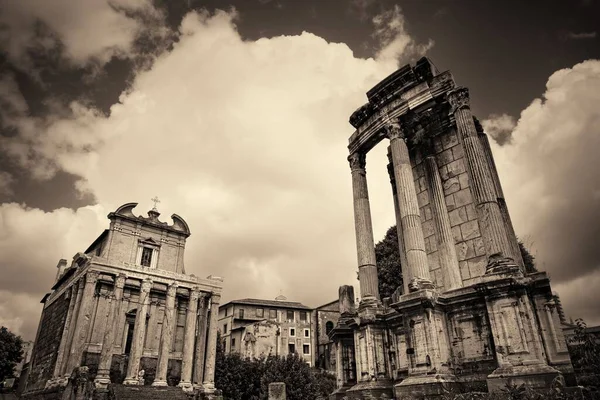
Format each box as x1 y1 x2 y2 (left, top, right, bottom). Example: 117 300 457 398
329 58 574 399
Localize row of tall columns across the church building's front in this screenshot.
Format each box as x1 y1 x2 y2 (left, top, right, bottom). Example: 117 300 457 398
49 271 220 392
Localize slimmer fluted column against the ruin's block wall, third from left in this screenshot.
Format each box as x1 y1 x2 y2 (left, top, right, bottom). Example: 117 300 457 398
423 152 462 290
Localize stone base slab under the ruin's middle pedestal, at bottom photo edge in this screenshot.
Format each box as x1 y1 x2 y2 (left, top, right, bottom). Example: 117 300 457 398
394 374 461 400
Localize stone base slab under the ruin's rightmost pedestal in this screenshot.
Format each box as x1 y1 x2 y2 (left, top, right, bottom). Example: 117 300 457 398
487 364 564 393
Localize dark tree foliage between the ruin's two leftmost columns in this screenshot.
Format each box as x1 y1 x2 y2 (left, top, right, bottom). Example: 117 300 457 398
375 225 403 299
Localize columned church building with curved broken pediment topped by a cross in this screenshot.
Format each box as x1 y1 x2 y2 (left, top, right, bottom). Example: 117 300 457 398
24 203 223 396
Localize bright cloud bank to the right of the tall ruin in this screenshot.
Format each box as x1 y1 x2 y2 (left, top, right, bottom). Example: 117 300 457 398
488 60 600 323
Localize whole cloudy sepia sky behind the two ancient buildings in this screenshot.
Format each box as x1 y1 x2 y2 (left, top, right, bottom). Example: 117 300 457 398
0 0 600 340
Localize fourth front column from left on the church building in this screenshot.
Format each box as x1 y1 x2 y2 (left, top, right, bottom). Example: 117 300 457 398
152 282 177 386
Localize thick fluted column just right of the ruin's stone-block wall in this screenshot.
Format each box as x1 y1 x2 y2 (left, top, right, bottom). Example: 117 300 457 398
448 87 511 267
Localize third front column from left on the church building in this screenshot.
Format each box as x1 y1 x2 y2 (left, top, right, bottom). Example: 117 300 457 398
123 279 152 385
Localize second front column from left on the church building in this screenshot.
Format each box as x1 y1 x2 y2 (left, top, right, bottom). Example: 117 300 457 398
94 274 126 389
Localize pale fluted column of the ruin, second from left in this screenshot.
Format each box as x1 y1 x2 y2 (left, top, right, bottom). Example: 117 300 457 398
385 122 434 292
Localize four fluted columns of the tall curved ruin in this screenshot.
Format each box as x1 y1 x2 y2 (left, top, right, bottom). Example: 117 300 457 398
348 87 516 299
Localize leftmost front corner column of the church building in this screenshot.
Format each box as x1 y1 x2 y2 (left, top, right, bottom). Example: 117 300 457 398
65 271 100 375
